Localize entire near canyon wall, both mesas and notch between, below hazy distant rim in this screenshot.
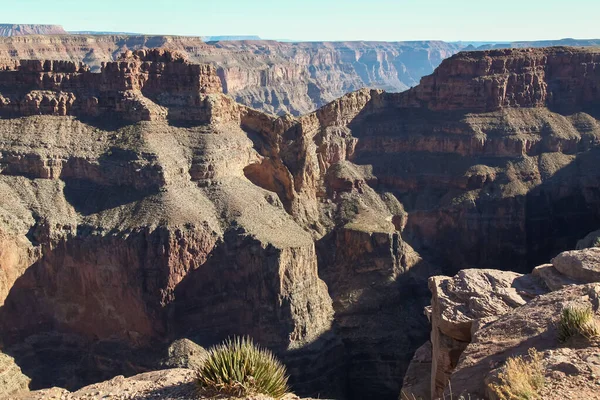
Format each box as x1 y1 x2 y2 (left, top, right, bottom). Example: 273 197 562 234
0 44 600 399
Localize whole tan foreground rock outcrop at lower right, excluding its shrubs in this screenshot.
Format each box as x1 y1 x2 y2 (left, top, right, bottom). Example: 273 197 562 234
420 249 600 399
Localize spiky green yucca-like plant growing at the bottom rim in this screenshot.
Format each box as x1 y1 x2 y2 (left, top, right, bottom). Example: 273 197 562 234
198 337 288 399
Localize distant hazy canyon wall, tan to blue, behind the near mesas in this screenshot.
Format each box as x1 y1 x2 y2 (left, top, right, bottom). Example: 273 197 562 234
0 35 460 115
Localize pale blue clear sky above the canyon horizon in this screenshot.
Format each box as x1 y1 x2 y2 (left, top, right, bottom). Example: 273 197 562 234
0 0 600 41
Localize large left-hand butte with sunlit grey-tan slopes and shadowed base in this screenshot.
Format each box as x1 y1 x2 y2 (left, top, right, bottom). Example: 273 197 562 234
0 51 340 396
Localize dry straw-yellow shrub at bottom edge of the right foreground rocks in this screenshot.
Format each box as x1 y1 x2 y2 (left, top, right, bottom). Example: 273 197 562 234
489 349 544 400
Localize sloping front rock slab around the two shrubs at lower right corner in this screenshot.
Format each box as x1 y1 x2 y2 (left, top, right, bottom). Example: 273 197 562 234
450 284 600 399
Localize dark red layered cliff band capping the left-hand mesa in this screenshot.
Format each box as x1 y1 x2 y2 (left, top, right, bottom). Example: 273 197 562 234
0 50 221 121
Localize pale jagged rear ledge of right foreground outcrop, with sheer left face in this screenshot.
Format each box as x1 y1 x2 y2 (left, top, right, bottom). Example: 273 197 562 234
426 250 600 398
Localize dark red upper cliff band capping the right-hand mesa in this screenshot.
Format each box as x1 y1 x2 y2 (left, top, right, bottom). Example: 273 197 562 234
411 47 600 112
